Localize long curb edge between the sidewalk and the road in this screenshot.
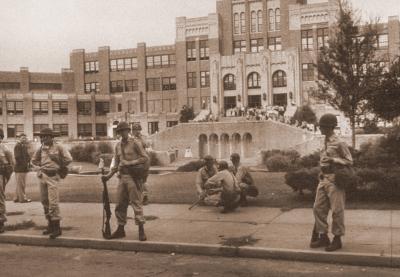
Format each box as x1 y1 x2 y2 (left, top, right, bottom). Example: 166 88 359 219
0 234 400 268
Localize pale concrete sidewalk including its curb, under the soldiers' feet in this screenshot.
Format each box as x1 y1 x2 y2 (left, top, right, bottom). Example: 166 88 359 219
0 202 400 267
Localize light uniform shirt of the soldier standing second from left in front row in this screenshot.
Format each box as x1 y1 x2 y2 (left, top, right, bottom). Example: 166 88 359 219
32 144 72 171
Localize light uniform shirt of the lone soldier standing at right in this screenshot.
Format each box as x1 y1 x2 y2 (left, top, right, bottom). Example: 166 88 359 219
320 135 353 167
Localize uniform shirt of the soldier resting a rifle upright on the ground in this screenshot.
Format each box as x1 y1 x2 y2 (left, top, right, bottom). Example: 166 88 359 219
112 138 149 172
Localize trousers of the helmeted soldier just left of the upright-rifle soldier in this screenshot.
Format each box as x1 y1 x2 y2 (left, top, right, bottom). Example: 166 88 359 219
39 173 61 221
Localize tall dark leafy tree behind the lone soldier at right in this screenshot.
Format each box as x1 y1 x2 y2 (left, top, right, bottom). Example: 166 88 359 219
313 0 383 147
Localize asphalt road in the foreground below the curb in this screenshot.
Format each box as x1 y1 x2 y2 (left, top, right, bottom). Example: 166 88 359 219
0 244 399 277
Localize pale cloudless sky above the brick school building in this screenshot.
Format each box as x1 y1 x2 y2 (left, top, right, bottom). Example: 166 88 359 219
0 0 400 72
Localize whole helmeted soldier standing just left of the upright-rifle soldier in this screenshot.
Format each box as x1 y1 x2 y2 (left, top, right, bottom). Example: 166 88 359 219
32 128 72 239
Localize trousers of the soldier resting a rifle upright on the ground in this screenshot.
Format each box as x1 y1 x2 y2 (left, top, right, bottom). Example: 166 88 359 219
115 174 145 225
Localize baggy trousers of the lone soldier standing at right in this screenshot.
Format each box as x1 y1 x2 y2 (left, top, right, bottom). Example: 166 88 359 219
314 174 346 236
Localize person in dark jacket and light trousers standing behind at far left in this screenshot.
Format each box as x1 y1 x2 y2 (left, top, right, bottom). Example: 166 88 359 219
14 134 31 203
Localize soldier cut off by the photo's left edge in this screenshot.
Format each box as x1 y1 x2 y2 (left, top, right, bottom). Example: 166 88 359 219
0 129 14 234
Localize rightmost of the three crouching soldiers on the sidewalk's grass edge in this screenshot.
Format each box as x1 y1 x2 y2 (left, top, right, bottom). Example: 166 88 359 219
230 153 258 207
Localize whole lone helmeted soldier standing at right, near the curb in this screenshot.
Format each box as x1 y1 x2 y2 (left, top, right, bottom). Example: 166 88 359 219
310 114 353 252
